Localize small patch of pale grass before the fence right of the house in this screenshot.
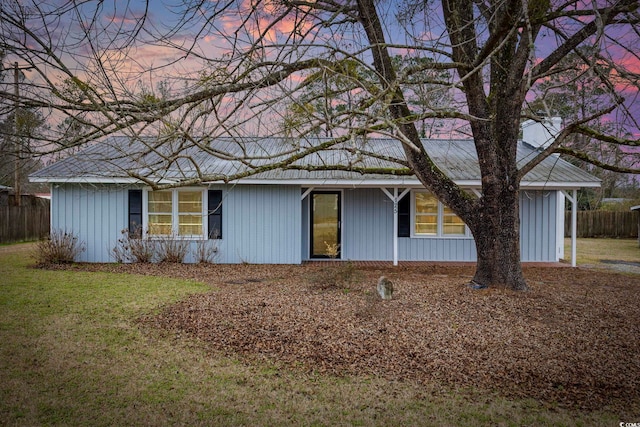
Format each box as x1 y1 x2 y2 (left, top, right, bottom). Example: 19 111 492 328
565 238 640 265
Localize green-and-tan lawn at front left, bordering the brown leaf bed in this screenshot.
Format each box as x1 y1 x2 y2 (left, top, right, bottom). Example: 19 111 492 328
0 244 622 426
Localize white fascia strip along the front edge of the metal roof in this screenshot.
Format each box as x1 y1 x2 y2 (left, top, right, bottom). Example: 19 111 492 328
29 177 600 190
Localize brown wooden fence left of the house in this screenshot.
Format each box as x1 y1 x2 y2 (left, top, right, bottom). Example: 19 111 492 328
0 199 51 243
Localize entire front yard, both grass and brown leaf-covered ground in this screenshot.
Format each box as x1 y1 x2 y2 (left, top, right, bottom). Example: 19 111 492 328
0 240 640 425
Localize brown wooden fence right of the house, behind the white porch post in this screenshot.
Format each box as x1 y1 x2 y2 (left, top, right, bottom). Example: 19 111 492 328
564 211 640 238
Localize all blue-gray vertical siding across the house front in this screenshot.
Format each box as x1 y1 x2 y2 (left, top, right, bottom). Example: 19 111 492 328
51 184 558 264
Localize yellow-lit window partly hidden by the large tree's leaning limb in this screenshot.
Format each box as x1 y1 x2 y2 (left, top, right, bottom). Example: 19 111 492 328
413 191 467 237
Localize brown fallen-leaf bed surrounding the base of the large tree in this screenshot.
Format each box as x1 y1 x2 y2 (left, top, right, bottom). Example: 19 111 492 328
77 263 640 415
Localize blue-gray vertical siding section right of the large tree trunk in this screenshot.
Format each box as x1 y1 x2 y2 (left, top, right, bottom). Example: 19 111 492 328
520 191 558 262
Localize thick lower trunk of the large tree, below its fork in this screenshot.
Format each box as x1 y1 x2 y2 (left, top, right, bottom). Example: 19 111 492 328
469 182 528 291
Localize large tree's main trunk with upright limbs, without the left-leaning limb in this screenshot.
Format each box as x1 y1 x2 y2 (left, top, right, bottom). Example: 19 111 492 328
443 0 530 290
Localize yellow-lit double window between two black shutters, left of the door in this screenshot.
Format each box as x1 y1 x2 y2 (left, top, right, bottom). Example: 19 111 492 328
146 188 206 238
